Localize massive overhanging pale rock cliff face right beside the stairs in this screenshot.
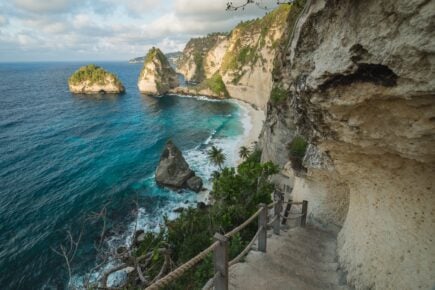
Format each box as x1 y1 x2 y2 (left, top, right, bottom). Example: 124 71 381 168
260 0 435 289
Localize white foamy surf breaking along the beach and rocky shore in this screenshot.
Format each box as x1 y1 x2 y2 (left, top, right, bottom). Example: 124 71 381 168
72 95 252 288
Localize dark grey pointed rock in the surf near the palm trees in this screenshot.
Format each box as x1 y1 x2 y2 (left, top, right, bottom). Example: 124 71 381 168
156 140 202 192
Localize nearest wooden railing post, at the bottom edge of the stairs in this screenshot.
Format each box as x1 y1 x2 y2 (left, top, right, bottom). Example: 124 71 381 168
213 233 228 290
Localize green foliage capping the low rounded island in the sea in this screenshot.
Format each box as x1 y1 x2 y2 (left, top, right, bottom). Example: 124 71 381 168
68 64 121 86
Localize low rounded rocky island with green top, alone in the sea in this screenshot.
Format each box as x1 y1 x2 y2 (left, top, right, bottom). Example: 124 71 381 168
68 64 125 94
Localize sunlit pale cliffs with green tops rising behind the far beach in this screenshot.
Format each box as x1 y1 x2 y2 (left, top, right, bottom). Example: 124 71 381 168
178 5 301 109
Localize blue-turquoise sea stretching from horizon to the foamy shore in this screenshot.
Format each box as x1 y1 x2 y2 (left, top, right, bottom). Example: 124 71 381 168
0 62 246 289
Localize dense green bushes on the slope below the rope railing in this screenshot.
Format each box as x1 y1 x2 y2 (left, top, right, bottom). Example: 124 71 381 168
128 148 278 290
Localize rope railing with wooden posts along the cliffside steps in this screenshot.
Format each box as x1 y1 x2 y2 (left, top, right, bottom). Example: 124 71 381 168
145 198 308 290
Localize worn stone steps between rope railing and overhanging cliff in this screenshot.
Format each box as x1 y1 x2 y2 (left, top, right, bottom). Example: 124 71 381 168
229 225 350 290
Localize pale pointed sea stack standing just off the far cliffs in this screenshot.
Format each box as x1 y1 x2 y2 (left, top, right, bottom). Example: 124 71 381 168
137 47 178 96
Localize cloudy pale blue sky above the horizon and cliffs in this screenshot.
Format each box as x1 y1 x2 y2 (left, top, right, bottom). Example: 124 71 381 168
0 0 276 62
